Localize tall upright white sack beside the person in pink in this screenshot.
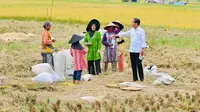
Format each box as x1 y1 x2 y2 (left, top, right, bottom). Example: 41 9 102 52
53 49 73 80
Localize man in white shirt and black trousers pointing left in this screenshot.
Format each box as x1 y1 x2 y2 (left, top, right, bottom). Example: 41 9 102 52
113 18 146 81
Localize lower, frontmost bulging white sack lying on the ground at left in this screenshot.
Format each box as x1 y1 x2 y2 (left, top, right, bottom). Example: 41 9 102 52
32 72 60 83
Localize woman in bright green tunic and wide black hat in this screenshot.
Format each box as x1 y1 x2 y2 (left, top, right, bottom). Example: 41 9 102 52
84 19 101 75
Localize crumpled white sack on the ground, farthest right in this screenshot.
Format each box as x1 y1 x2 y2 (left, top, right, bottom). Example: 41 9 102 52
153 72 175 85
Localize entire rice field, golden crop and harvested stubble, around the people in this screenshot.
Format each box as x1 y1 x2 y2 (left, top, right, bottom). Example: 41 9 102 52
0 0 200 112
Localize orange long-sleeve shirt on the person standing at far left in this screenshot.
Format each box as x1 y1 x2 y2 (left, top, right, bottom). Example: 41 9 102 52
42 30 53 53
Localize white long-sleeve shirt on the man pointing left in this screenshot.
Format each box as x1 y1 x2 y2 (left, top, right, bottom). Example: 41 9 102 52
118 27 146 53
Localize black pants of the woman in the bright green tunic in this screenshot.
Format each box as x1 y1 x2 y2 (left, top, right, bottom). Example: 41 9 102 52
88 60 101 75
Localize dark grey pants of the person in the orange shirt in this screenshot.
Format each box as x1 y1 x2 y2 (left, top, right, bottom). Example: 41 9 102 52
41 53 54 67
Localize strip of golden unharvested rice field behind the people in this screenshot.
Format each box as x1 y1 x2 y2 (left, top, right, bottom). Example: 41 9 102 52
0 0 200 30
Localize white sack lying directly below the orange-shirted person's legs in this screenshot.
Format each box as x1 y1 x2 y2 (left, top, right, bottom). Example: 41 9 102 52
32 63 56 75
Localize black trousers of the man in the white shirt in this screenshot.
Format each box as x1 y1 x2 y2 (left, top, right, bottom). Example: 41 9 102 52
130 53 144 81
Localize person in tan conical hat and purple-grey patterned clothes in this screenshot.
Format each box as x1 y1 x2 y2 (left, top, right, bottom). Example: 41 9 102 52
102 22 118 72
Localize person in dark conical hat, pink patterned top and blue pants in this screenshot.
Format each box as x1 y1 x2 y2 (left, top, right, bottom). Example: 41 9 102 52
68 34 87 84
